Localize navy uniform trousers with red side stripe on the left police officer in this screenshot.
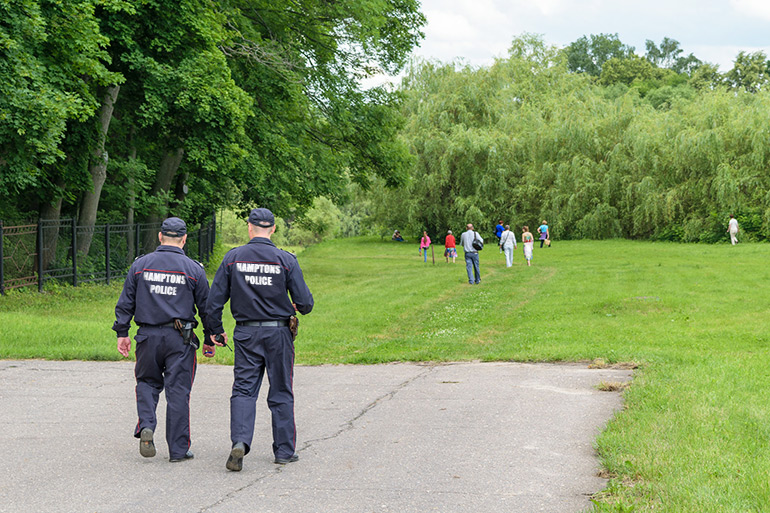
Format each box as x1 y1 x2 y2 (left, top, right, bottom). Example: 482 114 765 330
134 326 197 458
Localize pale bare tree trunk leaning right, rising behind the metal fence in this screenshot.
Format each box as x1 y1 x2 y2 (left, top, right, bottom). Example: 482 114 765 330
78 85 120 255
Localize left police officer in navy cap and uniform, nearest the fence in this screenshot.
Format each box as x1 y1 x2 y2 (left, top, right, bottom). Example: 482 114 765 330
112 217 209 462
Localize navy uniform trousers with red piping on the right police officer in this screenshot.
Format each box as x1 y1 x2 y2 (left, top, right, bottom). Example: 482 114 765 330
230 326 297 459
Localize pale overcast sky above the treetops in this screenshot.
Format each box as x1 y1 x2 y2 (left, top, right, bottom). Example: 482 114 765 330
404 0 770 72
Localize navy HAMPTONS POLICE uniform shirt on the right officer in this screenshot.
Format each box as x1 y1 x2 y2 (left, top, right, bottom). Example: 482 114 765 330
206 237 313 333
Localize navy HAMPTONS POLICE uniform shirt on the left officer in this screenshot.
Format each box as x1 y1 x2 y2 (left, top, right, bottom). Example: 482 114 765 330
112 245 209 337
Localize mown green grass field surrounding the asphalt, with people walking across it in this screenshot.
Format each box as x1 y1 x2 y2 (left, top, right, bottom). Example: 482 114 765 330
0 239 770 512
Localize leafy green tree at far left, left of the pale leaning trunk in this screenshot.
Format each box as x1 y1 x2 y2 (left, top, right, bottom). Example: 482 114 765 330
0 0 122 220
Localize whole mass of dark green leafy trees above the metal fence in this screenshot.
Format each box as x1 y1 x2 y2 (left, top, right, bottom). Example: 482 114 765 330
0 0 425 234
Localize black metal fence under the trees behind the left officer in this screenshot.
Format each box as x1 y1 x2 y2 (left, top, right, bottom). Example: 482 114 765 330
0 215 216 294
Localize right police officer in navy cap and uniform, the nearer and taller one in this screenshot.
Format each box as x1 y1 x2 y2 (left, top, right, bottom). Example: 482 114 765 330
206 208 313 471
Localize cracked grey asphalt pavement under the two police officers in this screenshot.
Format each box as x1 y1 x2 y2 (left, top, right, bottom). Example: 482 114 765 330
0 360 631 513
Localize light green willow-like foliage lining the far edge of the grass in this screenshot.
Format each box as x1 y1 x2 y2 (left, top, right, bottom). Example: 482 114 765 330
373 36 770 242
